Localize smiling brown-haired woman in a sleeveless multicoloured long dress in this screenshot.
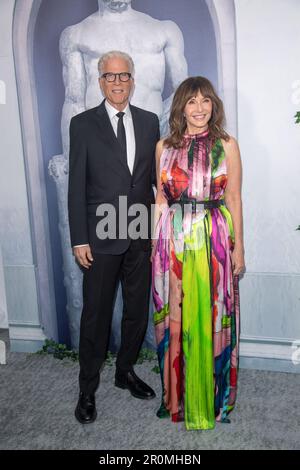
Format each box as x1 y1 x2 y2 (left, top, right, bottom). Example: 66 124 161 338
151 77 245 429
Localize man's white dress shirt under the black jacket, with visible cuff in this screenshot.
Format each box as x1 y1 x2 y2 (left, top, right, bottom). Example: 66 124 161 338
73 100 135 248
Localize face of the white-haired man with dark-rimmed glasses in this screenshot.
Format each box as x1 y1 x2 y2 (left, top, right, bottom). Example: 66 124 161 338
99 57 133 111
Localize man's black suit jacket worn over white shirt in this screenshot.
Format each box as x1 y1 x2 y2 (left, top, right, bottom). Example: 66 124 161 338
68 101 159 254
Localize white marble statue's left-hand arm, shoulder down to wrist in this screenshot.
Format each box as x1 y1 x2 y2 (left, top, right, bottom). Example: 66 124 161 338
59 26 86 158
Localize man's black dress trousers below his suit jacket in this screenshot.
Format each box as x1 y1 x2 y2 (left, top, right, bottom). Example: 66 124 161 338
79 241 151 394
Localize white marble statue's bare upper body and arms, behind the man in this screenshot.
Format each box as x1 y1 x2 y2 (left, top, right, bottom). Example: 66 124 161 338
60 0 187 151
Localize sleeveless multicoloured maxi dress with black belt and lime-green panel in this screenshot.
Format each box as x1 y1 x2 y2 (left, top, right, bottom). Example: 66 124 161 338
152 131 239 429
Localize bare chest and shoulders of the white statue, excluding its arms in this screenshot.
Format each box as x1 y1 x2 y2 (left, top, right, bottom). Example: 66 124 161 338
67 11 167 115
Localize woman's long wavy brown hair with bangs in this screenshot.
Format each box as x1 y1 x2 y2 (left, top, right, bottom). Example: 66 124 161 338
164 77 230 148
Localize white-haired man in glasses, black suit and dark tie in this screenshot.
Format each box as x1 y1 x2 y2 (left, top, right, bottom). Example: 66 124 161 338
68 51 159 423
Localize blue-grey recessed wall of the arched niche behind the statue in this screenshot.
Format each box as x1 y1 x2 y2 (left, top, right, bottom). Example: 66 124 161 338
34 0 218 344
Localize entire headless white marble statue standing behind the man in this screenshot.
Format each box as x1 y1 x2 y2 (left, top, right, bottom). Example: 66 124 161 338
49 0 187 347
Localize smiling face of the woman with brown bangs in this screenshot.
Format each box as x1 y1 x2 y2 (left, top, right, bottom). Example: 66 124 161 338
184 91 212 134
